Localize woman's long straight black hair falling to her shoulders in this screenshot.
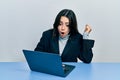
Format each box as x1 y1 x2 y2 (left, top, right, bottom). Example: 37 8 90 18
53 9 79 36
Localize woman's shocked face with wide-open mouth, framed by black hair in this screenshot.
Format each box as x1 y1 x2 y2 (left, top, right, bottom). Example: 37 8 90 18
58 16 70 38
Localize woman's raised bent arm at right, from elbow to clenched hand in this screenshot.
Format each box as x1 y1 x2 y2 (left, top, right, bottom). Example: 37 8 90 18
80 25 95 63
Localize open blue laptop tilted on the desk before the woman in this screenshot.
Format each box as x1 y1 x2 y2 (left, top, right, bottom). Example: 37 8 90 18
23 50 75 77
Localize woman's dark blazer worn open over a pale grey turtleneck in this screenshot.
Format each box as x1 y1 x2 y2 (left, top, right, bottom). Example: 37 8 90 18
35 29 94 63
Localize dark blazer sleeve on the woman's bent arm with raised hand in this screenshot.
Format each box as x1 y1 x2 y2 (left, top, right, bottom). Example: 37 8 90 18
80 39 95 63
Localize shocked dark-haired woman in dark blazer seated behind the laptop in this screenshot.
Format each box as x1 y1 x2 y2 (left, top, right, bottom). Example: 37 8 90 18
35 9 94 63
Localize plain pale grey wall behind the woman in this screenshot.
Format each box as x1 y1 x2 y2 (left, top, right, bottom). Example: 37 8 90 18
0 0 120 62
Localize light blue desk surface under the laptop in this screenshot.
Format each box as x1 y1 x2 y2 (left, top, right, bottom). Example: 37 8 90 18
0 62 120 80
